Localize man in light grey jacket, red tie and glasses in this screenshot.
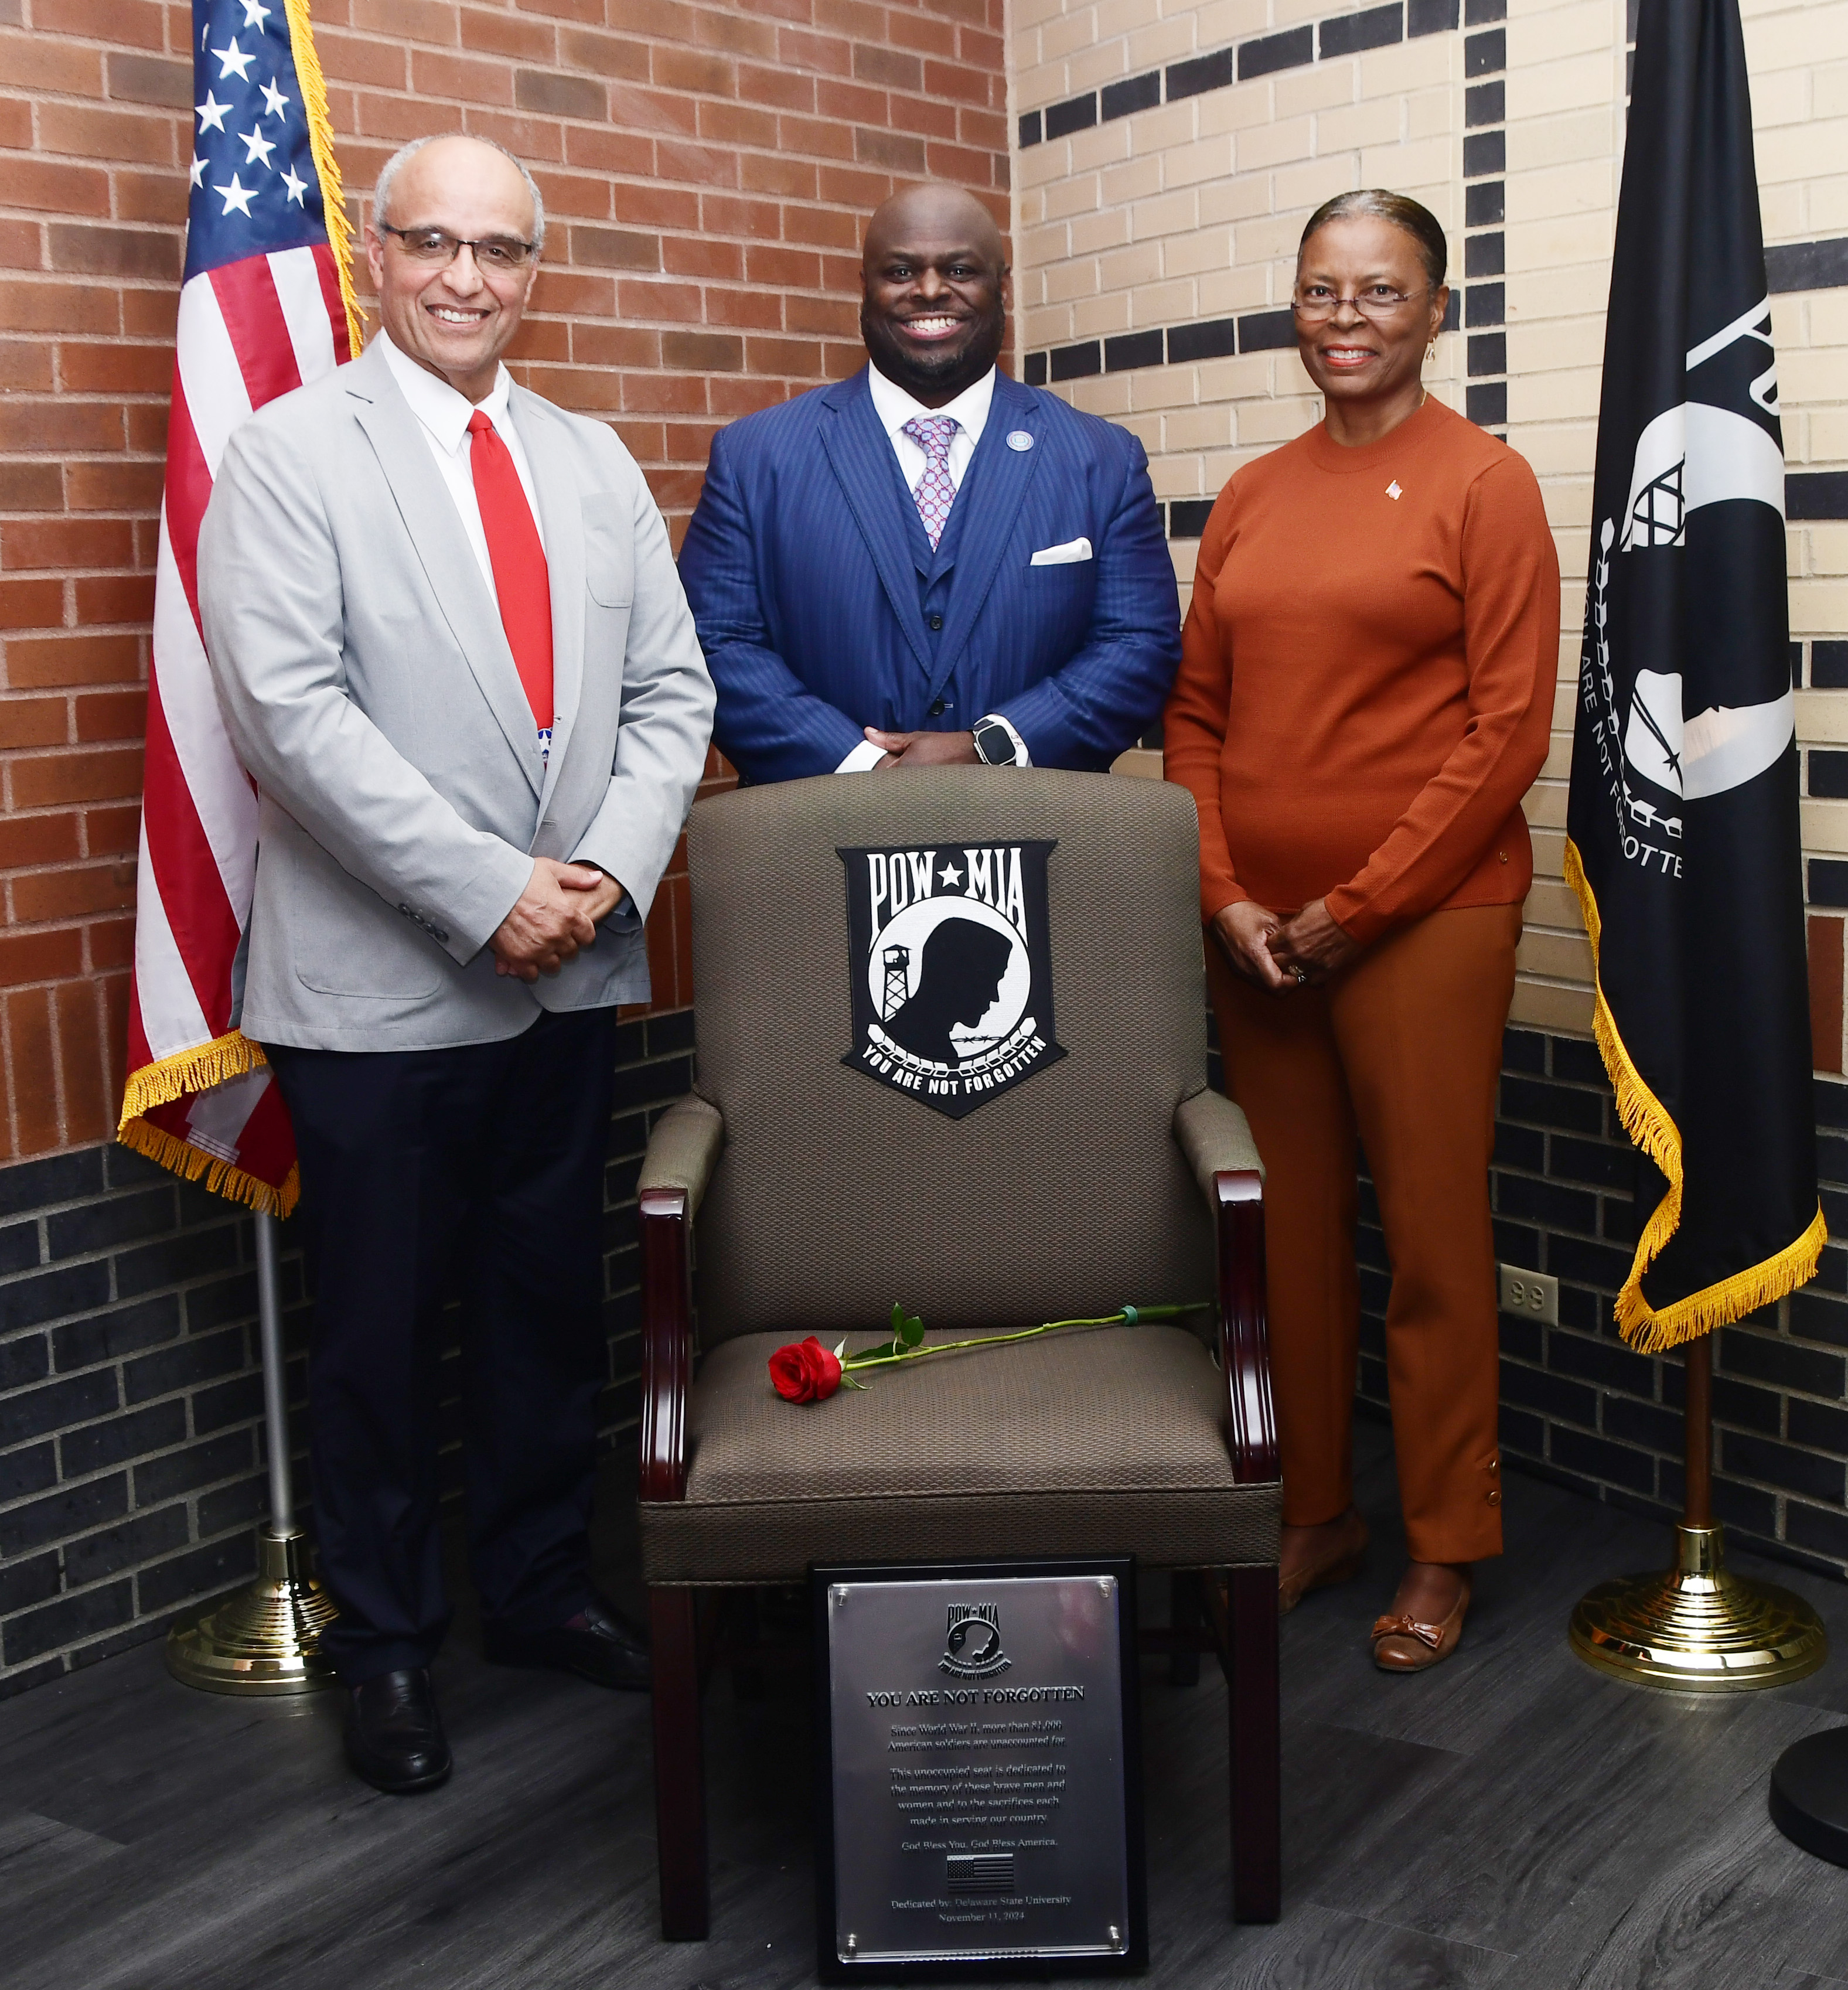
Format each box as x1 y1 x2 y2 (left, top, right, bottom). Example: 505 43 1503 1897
199 137 712 1791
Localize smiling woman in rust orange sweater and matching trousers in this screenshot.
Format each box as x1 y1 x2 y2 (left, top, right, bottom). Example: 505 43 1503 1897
1164 191 1560 1672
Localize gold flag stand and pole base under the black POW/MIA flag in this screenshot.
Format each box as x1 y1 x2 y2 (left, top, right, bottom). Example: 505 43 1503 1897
1570 1333 1828 1693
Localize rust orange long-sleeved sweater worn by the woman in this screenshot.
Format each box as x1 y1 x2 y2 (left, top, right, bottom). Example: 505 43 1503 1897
1164 400 1560 945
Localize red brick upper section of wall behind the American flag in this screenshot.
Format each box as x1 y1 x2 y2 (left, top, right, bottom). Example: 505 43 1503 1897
0 0 1008 1162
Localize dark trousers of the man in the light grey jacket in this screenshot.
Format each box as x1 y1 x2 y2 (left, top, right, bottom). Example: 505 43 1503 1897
265 1009 616 1684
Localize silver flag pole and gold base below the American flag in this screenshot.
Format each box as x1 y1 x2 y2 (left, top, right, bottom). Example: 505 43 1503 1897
167 1210 336 1693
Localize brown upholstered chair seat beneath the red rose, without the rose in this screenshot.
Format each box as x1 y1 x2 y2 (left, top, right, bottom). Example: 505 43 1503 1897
640 1325 1281 1584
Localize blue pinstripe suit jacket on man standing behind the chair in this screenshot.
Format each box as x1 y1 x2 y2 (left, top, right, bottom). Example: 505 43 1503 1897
680 370 1179 782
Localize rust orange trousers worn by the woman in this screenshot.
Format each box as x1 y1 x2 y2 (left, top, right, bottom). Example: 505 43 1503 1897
1205 905 1522 1562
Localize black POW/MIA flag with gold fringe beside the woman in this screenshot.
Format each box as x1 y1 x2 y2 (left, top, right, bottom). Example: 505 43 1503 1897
1566 0 1826 1351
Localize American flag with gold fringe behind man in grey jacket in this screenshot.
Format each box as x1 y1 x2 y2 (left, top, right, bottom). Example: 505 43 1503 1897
117 0 358 1216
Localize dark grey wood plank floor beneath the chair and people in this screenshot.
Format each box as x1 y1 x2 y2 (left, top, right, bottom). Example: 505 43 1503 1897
11 1427 1848 1990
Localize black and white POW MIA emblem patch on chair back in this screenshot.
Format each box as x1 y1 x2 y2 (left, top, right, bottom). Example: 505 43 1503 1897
840 844 1064 1119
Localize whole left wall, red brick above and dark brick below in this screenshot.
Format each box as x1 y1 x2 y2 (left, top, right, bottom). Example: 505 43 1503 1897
0 0 1011 1693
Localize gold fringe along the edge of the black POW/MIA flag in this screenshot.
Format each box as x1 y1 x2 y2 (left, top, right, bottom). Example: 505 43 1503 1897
1566 836 1828 1355
